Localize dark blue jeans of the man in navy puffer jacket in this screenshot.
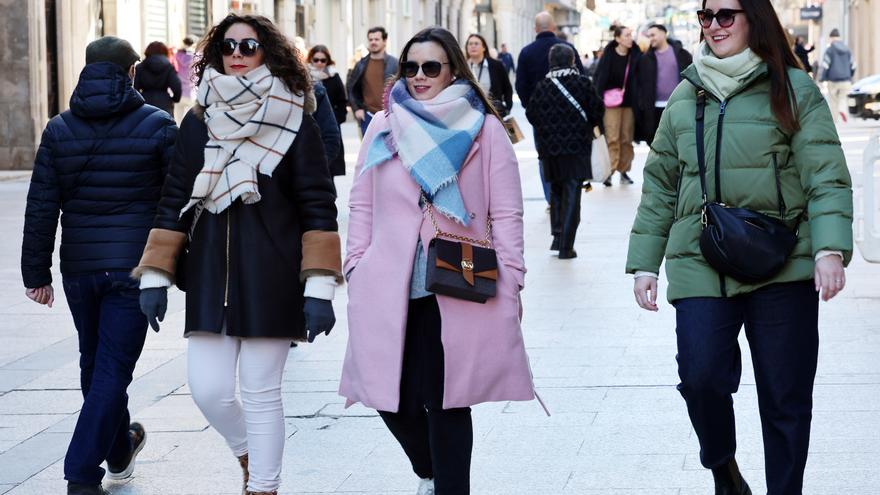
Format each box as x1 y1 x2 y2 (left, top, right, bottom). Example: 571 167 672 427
63 272 147 484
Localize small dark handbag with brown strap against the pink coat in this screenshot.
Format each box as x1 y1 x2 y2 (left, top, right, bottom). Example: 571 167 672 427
422 195 498 304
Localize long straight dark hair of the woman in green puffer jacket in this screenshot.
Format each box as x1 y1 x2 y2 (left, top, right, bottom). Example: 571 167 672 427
700 0 803 132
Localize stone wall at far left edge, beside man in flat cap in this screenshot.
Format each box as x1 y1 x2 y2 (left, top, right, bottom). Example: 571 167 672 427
0 0 36 170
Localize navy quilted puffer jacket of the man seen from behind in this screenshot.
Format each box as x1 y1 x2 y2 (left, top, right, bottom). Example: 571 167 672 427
21 62 177 288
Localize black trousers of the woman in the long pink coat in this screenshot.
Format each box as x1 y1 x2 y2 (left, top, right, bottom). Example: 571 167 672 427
379 296 474 495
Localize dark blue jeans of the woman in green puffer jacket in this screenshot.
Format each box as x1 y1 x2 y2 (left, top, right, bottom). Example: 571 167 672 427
674 281 819 495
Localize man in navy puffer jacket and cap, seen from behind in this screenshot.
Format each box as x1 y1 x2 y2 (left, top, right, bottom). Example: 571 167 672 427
21 36 177 495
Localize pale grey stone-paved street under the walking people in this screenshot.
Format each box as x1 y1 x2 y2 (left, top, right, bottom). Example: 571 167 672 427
0 102 880 495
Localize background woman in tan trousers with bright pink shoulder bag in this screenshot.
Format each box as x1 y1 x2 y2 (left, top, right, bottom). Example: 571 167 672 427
593 26 642 186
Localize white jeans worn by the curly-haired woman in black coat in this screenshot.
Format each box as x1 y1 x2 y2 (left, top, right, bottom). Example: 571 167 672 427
187 332 290 492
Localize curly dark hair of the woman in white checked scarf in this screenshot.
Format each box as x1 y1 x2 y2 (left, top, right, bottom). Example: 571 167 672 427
193 14 311 96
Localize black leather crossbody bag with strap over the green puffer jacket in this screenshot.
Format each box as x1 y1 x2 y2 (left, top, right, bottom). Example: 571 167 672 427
696 91 797 283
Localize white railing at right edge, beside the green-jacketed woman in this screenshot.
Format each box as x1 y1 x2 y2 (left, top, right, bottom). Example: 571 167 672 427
853 134 880 263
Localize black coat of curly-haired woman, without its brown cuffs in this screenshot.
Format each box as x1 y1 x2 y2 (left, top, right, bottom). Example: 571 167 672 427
154 107 337 340
